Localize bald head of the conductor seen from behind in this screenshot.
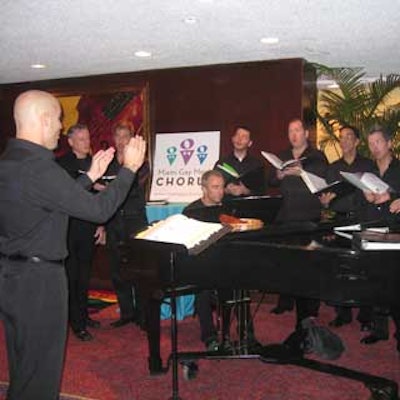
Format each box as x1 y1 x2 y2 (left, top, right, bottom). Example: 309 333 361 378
14 90 61 150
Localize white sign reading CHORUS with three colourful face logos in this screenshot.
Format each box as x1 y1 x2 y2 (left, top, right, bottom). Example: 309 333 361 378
150 131 220 203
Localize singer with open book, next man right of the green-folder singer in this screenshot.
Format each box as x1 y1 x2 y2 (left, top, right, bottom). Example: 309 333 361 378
269 118 328 327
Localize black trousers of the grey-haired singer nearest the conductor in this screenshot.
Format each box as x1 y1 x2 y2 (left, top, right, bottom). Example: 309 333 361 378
65 233 95 332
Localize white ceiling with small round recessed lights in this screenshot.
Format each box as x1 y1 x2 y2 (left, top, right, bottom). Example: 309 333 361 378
0 0 400 84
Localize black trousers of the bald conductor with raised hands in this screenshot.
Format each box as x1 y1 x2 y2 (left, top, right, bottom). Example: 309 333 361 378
0 259 68 400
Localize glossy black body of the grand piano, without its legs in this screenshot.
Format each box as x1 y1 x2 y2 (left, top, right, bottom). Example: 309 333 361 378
123 223 400 306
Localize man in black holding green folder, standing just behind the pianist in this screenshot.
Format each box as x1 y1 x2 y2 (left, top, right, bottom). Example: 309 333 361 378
214 126 265 197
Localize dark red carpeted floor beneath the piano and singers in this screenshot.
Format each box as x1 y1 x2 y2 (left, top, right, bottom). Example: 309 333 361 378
0 303 400 400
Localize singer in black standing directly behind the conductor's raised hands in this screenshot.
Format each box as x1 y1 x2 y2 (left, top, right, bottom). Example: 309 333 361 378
106 124 149 328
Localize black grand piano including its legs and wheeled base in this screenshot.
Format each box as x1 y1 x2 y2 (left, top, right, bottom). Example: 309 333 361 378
122 200 400 400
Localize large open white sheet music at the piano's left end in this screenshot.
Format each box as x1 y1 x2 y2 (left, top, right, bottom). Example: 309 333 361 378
135 214 232 255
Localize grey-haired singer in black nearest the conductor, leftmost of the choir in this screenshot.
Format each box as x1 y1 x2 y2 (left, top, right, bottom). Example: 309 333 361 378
57 124 104 341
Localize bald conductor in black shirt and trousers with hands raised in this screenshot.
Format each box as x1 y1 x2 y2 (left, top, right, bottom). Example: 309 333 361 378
0 90 145 400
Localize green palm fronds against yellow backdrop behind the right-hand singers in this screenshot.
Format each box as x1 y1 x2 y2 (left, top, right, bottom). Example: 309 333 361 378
315 64 400 156
